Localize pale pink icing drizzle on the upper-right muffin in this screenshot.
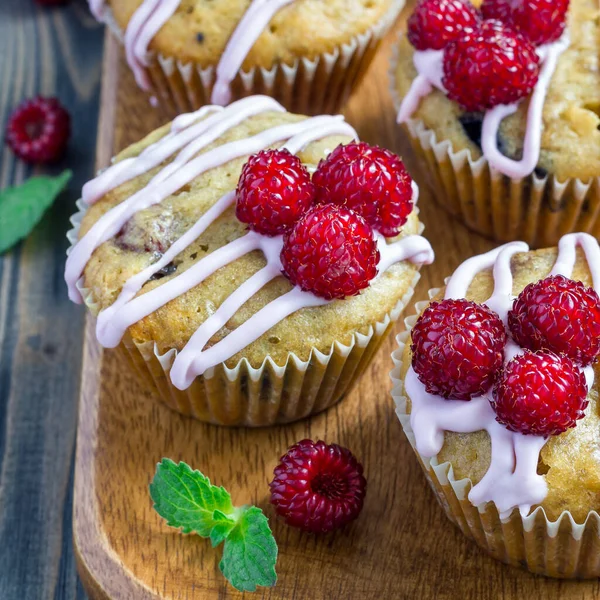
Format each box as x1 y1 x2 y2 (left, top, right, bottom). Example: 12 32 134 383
397 31 570 178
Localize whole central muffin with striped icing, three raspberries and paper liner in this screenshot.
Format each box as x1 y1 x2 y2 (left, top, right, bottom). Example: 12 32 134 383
65 96 433 426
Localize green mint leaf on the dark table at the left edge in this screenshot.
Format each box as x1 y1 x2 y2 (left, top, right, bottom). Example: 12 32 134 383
0 171 72 254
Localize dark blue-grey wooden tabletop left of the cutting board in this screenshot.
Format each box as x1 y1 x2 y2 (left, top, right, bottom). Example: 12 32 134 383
0 0 103 600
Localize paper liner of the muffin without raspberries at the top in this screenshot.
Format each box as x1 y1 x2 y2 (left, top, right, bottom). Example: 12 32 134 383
104 0 405 115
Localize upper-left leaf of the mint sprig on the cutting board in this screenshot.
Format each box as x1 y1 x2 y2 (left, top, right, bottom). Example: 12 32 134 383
150 458 234 537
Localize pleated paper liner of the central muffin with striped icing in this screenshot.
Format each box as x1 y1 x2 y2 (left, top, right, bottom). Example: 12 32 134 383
67 202 423 427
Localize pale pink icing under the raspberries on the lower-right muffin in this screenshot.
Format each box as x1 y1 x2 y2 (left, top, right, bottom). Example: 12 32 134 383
405 233 600 519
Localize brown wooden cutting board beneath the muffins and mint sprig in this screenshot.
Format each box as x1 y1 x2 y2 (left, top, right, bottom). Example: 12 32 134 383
74 7 600 600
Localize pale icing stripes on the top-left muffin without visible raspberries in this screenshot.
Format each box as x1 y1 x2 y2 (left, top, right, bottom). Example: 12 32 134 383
88 0 294 106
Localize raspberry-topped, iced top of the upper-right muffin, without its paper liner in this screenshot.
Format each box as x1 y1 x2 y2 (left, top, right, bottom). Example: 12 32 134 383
394 0 600 181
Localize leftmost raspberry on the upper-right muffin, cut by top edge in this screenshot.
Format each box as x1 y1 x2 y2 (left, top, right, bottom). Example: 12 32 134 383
408 0 479 50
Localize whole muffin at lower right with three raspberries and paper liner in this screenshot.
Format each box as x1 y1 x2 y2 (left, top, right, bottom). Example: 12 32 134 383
392 233 600 578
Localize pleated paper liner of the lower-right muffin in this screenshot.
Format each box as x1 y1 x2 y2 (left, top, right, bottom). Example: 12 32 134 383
391 289 600 579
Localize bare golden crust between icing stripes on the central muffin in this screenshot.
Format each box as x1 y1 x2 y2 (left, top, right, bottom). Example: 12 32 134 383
79 101 421 366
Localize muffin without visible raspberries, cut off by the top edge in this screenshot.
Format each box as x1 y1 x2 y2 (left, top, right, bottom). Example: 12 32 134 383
90 0 404 114
